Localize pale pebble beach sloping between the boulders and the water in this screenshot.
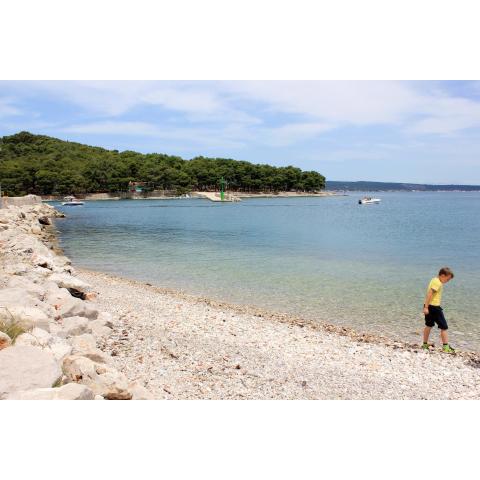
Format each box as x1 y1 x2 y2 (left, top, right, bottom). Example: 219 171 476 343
79 270 480 400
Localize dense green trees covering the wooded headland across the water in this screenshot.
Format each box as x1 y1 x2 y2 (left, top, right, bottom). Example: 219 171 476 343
0 132 325 195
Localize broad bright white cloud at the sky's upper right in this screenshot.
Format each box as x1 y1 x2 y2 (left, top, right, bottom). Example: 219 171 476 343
225 81 480 134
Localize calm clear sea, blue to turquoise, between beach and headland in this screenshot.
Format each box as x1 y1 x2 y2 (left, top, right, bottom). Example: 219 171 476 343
57 192 480 350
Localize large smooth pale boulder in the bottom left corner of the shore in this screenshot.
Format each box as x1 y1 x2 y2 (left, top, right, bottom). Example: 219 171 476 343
0 346 62 399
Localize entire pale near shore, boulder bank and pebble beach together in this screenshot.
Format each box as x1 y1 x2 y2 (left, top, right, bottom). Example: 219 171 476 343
0 205 480 399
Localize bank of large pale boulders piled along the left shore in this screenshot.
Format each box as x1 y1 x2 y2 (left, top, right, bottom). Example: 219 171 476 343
0 203 152 400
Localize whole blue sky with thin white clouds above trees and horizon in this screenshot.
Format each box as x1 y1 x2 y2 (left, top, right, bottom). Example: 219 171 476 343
0 81 480 184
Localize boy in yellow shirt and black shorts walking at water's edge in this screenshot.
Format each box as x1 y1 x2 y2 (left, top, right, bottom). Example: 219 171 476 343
422 267 455 353
